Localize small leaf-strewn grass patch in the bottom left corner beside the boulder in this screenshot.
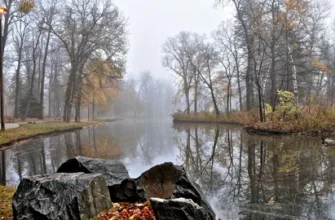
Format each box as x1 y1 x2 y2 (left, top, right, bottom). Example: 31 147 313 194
0 185 16 220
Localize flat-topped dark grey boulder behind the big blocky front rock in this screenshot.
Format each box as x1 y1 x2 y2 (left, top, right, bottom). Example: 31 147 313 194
57 156 130 186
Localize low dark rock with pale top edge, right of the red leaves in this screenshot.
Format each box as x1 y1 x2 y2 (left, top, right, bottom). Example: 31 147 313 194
150 198 214 220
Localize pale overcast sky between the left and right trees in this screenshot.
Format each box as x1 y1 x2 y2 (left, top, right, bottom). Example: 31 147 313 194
114 0 335 79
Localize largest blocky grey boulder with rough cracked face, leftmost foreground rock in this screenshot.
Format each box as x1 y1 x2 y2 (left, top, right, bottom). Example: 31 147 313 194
13 173 112 220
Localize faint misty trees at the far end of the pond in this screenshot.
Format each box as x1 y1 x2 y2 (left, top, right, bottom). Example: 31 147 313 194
111 71 175 119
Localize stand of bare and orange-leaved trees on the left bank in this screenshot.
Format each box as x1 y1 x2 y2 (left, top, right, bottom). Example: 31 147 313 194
2 0 127 122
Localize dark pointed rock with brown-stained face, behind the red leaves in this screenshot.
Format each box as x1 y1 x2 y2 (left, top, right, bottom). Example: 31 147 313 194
136 163 215 220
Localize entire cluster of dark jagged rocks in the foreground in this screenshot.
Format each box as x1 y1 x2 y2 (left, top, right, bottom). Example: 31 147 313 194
13 157 215 220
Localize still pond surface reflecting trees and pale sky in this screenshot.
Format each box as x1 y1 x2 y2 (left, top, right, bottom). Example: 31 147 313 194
0 120 335 220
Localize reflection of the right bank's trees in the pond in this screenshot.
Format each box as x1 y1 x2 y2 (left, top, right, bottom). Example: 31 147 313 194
175 125 335 219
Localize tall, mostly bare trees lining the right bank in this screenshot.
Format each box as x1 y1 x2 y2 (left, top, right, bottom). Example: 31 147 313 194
163 0 335 121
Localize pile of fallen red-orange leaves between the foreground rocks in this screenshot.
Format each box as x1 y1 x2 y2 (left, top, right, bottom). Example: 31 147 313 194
94 201 156 220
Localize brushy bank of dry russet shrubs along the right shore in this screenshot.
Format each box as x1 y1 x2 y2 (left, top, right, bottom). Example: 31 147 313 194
173 106 335 136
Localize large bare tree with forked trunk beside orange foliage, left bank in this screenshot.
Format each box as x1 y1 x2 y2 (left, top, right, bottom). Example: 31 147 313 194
49 0 126 122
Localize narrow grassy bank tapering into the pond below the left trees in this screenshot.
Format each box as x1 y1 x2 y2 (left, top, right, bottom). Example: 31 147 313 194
0 121 101 149
